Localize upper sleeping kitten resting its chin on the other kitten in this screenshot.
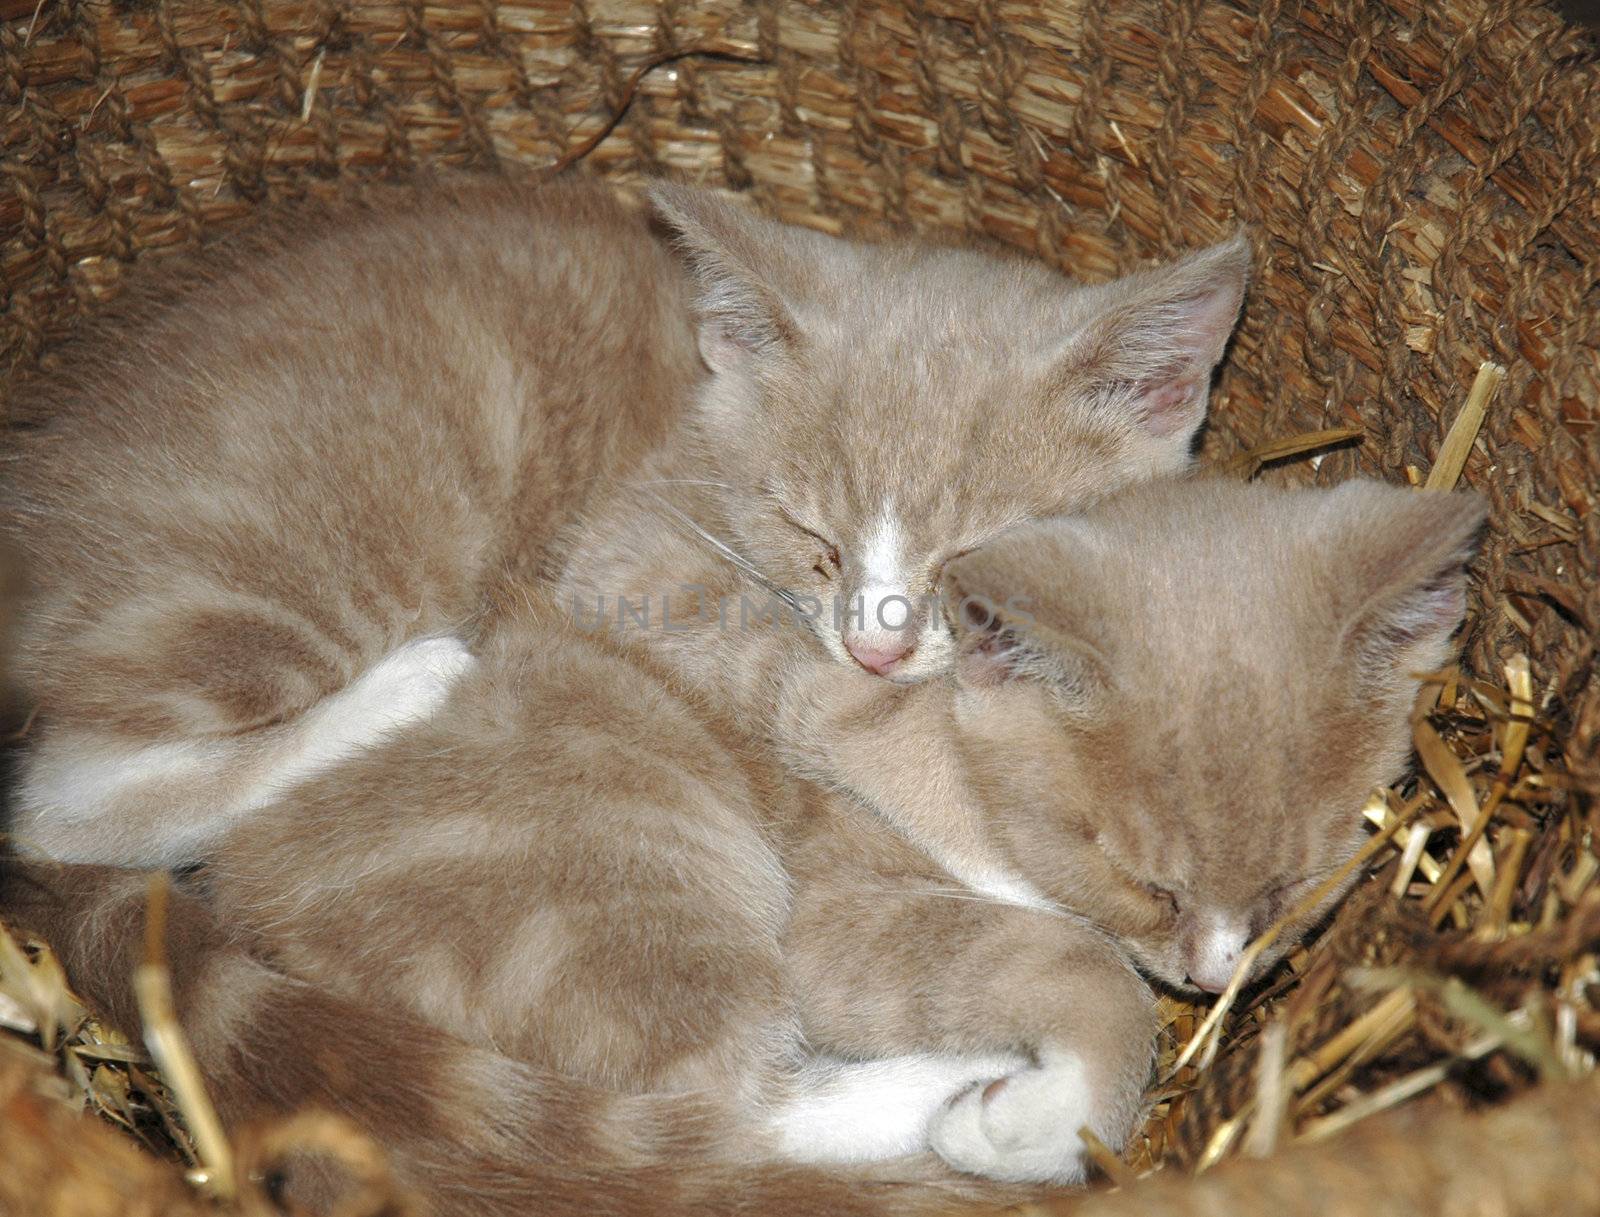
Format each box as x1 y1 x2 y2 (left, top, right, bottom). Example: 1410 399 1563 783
0 184 1248 864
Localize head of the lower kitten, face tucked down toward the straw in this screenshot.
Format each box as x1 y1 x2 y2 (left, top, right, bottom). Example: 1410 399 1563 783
946 480 1485 992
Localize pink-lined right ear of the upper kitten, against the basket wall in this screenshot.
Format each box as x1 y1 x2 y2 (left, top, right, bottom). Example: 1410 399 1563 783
1066 232 1250 470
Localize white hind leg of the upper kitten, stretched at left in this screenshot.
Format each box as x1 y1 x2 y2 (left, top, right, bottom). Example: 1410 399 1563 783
11 636 477 865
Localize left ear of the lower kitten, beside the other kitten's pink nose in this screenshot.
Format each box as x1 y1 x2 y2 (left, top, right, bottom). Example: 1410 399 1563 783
939 521 1110 712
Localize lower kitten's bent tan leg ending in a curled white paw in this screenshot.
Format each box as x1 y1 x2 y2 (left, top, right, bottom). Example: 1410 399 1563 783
787 808 1155 1182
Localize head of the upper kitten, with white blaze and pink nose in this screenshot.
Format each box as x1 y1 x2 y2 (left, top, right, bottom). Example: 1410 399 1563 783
653 187 1250 681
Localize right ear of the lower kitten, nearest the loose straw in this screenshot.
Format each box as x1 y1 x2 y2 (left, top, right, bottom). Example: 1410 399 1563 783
1325 480 1488 676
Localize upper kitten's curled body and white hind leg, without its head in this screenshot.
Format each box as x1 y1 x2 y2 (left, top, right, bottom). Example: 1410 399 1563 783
0 182 702 864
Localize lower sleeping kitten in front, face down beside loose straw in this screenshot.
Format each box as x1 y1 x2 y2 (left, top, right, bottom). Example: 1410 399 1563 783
3 481 1483 1214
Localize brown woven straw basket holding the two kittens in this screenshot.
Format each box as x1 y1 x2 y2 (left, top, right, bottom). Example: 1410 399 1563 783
0 0 1600 1214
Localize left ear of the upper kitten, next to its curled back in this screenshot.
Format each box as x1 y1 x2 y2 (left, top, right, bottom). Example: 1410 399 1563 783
650 182 805 373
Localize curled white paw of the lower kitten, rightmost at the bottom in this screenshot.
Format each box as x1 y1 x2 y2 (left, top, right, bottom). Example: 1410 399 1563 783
928 1051 1093 1183
